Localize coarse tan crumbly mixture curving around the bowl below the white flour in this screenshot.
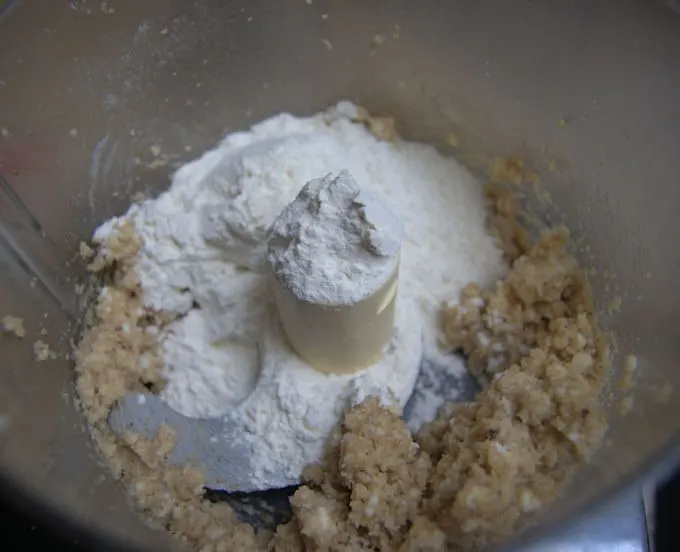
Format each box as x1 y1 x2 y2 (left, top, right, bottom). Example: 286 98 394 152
76 178 608 552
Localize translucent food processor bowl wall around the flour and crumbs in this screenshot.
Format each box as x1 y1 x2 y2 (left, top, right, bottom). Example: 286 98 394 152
0 0 680 548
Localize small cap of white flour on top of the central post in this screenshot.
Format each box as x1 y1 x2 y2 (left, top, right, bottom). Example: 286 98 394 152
269 171 403 305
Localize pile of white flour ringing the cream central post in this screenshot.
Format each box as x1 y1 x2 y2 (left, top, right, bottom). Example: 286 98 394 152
95 102 505 488
